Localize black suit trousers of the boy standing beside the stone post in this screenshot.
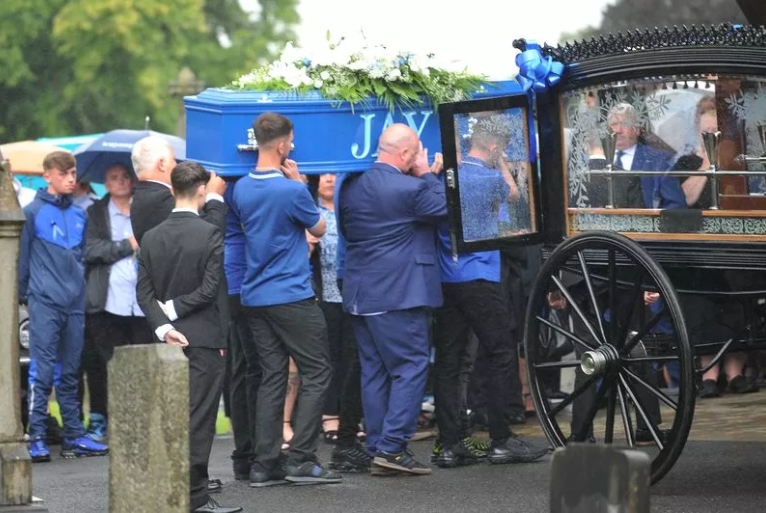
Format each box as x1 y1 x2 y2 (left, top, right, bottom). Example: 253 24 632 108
184 347 226 510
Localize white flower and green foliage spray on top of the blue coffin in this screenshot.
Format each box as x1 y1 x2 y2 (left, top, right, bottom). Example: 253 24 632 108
230 34 488 111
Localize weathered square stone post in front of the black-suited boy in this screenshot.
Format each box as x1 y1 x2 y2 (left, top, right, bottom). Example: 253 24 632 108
107 344 189 513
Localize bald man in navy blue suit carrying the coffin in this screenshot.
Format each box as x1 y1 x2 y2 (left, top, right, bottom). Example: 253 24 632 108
338 124 447 475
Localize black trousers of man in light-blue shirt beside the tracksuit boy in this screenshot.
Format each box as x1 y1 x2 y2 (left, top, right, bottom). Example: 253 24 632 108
80 312 153 416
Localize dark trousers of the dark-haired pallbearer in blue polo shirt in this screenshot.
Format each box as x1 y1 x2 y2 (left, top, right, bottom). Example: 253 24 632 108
245 298 332 471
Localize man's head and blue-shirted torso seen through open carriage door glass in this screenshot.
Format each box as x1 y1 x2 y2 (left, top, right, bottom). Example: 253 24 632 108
458 115 519 241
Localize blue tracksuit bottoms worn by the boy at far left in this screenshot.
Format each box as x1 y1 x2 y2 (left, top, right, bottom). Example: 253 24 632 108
29 297 85 440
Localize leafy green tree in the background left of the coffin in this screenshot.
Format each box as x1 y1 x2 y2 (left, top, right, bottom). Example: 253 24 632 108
0 0 298 141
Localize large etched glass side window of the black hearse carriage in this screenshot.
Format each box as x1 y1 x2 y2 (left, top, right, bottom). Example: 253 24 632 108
561 75 766 241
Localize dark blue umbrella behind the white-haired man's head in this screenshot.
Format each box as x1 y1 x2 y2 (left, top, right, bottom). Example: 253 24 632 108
74 130 186 183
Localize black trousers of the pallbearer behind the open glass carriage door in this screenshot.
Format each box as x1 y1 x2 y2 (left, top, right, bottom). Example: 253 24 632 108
434 280 518 447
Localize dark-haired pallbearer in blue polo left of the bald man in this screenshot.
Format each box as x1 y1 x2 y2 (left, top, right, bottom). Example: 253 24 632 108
231 113 341 487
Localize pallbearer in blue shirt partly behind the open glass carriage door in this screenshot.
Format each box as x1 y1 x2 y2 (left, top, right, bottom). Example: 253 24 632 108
432 115 548 468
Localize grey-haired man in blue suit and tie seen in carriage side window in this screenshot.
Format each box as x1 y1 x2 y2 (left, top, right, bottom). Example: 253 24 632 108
607 103 686 208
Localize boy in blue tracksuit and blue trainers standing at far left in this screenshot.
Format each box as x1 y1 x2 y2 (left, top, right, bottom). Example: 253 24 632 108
19 151 109 462
